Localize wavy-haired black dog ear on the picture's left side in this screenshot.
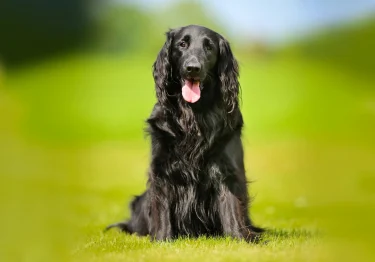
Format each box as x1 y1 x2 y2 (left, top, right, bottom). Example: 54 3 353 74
153 30 174 104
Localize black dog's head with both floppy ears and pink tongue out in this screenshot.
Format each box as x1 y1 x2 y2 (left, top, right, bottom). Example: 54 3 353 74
153 25 239 112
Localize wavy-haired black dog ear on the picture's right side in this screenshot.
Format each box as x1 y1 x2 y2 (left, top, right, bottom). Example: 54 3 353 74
218 37 240 113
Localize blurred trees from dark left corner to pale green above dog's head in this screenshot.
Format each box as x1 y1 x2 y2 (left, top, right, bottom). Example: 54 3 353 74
0 0 222 66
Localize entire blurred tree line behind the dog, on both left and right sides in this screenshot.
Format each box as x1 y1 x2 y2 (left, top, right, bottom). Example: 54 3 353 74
0 0 375 81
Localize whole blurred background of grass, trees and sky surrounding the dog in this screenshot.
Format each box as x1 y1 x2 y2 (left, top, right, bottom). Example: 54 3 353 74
0 0 375 261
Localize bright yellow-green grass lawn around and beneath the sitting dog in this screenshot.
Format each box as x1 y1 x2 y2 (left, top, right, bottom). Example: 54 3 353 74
0 52 375 261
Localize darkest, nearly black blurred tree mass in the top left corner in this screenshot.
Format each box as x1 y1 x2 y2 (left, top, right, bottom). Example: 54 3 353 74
0 0 93 65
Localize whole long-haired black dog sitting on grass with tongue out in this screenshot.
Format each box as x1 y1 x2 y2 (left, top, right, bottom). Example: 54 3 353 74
108 25 262 241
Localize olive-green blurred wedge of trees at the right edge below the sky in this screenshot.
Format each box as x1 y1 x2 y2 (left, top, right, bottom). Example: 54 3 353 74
281 17 375 80
